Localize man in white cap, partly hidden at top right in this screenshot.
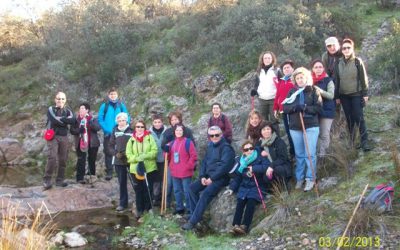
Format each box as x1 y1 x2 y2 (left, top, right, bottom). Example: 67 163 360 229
322 36 343 78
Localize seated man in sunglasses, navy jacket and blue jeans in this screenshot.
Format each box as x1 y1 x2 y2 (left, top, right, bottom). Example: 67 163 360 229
182 126 235 230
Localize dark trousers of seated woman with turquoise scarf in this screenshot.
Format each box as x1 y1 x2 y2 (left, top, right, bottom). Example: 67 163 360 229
232 198 259 231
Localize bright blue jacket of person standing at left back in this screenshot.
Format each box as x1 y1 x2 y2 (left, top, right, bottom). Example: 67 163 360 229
98 101 129 136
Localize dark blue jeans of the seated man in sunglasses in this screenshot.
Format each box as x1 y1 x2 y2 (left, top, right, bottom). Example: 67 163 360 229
189 178 229 225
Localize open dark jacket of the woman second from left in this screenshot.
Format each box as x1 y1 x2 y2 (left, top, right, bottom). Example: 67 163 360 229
69 116 101 148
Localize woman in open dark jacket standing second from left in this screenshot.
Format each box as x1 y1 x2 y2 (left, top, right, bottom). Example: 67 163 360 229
70 103 100 184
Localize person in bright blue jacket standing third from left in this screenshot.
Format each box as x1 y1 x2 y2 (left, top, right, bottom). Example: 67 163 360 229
98 88 129 181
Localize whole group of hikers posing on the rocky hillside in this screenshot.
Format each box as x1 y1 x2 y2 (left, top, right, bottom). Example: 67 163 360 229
43 37 370 235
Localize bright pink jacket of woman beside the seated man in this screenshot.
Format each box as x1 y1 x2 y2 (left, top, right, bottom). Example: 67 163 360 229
168 137 197 178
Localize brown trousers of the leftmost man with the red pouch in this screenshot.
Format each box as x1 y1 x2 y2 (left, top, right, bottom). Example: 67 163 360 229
43 135 69 185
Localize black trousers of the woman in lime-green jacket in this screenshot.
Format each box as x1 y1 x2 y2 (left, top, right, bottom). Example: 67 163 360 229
132 171 156 213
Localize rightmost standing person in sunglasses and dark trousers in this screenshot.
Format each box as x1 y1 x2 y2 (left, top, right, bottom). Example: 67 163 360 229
335 38 371 152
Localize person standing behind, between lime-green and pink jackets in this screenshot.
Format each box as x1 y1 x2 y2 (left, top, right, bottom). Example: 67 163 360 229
149 115 167 206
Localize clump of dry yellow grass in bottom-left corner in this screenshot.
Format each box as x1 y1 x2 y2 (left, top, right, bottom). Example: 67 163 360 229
0 203 54 250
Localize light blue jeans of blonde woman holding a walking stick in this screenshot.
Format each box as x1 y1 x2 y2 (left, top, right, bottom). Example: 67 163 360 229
290 127 319 181
